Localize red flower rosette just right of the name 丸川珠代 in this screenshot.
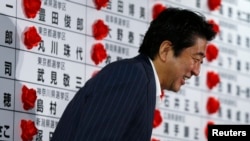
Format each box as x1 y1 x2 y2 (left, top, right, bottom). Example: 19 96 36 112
91 43 107 65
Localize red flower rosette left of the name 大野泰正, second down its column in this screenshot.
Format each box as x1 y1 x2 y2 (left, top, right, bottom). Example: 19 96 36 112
92 20 109 40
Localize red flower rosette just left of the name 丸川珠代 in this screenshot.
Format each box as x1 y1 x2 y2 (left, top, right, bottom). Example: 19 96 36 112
24 26 42 49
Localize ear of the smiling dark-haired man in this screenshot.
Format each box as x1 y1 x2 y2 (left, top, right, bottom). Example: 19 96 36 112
159 40 172 61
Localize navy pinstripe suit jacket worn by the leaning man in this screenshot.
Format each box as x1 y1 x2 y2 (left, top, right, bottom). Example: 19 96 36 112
52 55 156 141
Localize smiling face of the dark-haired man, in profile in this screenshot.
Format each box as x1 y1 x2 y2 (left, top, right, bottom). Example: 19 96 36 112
161 38 207 92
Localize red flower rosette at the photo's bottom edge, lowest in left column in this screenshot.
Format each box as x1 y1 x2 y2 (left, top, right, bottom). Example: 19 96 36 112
20 120 38 141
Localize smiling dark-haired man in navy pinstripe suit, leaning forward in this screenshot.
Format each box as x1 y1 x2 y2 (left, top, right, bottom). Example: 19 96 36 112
52 8 216 141
